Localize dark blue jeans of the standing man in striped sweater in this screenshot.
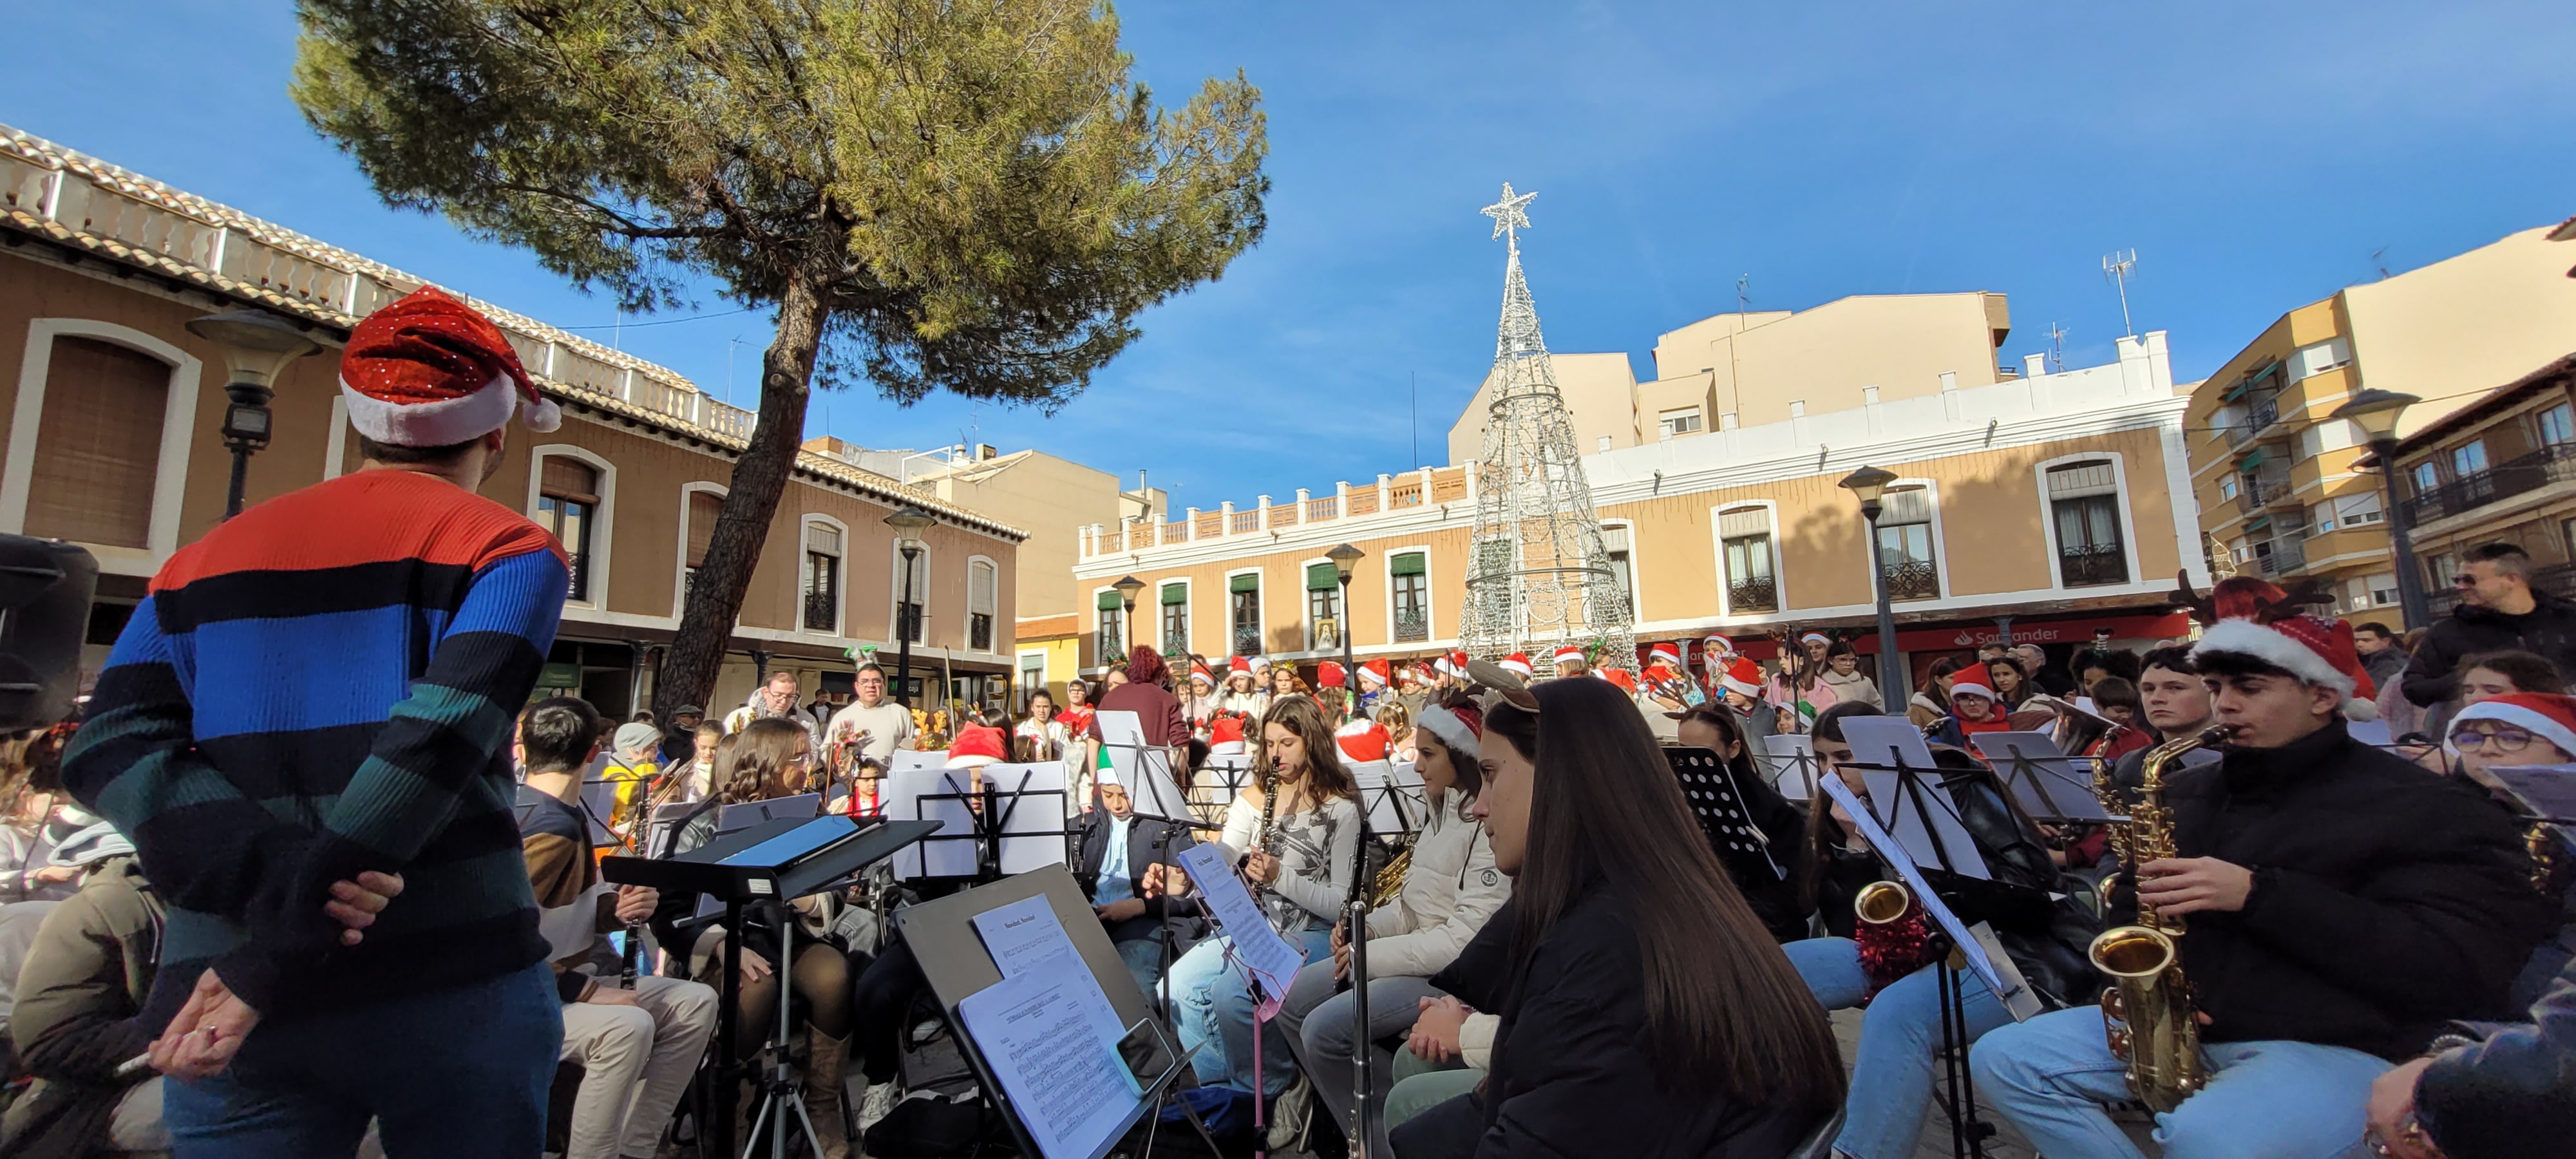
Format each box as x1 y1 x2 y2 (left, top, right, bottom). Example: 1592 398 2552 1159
162 963 564 1159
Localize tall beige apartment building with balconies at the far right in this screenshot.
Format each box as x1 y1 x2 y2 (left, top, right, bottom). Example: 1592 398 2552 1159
2184 227 2576 626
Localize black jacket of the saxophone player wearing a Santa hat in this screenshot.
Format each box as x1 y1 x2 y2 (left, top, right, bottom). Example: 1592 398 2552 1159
2112 721 2555 1059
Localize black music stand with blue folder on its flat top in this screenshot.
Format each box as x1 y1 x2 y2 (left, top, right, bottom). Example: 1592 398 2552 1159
600 816 940 1156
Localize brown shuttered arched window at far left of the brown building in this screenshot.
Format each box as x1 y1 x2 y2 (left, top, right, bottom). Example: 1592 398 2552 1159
26 337 170 549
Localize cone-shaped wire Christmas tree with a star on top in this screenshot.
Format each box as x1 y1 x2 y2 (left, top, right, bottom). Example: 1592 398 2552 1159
1458 183 1636 670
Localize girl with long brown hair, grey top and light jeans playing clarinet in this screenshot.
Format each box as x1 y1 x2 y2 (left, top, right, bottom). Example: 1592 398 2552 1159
1146 695 1360 1097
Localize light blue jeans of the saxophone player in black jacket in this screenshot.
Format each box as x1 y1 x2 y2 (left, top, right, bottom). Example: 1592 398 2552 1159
1968 1007 2388 1159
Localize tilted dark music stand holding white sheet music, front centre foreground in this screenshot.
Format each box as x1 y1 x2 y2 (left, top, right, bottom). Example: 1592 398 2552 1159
894 865 1216 1159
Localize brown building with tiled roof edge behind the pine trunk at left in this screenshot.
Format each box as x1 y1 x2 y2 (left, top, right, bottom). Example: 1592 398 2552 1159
0 129 1028 716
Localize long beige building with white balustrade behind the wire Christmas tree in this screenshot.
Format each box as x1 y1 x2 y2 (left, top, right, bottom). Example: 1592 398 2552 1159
1074 332 2205 685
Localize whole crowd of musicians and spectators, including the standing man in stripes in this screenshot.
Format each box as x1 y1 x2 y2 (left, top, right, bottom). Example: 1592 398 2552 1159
0 278 2576 1159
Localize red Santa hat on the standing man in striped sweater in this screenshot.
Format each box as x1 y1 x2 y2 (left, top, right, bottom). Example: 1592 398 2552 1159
340 286 564 446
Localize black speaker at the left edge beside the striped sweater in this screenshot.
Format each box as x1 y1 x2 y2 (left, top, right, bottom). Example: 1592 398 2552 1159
0 536 98 731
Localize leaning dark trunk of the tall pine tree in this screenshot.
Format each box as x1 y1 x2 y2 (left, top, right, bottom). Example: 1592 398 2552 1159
652 273 824 721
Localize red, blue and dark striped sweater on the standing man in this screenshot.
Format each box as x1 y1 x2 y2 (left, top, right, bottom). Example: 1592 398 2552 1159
62 469 569 1017
